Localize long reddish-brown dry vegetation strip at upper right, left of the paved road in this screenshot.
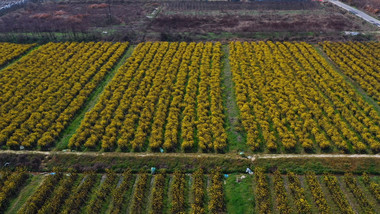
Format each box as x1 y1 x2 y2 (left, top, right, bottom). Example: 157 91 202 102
152 13 361 32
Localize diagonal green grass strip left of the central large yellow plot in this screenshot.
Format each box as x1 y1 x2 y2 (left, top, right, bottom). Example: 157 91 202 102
54 46 134 151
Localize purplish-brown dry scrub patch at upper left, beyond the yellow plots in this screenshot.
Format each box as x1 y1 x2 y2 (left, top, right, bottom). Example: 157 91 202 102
0 3 151 32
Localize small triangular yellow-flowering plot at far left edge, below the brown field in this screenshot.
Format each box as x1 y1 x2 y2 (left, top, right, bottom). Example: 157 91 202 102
0 42 36 66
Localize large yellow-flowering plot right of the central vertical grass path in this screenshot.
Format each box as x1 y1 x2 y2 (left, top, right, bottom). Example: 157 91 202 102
229 42 380 153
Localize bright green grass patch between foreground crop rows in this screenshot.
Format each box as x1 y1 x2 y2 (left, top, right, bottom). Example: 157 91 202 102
224 174 255 214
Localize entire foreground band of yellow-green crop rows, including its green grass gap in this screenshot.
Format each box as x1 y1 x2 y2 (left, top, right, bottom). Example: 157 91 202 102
0 168 380 214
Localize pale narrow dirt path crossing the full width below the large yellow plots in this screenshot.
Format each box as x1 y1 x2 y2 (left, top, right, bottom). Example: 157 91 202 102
0 150 380 161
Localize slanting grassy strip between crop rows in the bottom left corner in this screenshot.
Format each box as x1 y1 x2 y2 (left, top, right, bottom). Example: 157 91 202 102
5 175 44 214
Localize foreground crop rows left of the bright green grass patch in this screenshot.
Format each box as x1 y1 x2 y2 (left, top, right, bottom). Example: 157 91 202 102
0 170 226 214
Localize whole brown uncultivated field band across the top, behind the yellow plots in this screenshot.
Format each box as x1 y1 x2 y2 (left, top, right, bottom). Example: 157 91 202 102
0 1 376 43
